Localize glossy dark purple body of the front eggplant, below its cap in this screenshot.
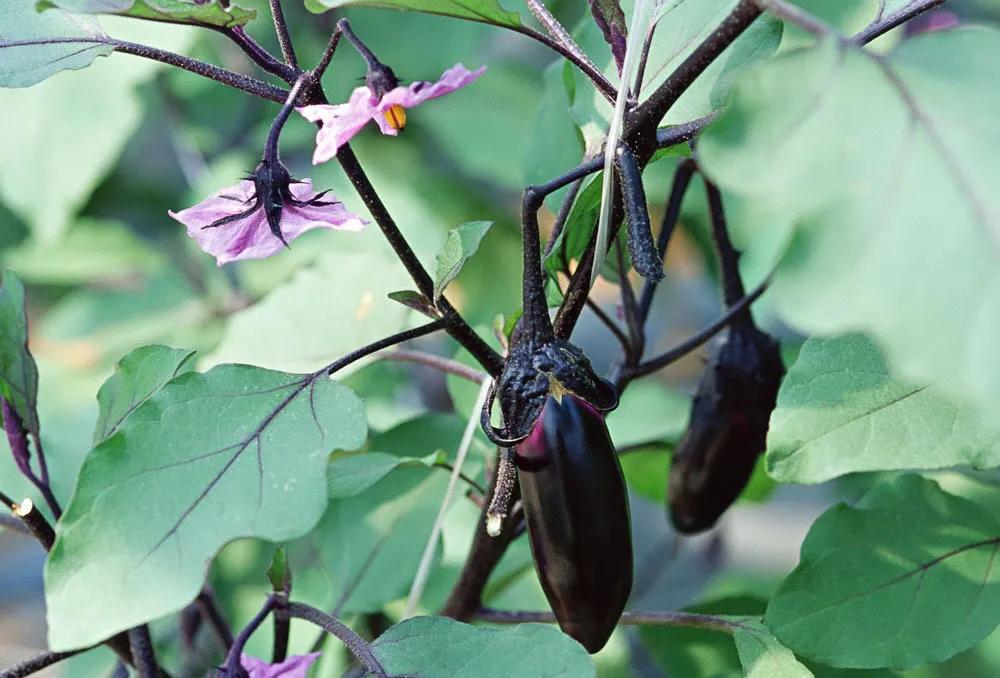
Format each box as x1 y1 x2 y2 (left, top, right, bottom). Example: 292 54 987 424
515 394 632 653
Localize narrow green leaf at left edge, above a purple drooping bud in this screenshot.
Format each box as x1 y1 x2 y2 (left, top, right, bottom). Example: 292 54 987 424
0 271 38 440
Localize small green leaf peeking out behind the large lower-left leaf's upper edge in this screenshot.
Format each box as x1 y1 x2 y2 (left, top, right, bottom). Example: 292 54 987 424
93 346 194 445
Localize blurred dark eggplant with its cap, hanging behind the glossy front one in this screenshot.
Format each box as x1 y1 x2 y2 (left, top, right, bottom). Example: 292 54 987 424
667 315 785 534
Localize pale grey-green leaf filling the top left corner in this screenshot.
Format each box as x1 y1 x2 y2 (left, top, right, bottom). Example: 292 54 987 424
0 1 114 87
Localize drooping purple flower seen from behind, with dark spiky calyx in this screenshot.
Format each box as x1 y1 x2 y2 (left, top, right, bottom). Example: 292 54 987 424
170 160 366 266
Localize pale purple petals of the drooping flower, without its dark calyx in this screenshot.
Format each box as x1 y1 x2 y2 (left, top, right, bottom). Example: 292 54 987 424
169 179 365 266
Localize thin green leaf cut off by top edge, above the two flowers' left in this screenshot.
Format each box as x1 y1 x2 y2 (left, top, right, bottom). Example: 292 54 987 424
37 0 257 28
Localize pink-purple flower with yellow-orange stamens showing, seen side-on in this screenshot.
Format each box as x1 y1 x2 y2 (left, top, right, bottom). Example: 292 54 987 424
298 64 486 164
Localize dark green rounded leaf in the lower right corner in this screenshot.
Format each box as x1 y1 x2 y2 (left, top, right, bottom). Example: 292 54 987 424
765 475 1000 669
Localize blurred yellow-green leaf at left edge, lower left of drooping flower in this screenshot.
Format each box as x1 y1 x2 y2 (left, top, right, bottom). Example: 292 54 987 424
3 219 163 285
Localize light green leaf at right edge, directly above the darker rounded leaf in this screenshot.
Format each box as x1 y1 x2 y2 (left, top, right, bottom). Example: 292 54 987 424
767 334 1000 483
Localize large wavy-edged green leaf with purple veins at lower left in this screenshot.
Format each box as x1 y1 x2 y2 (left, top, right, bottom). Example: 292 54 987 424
45 365 367 649
